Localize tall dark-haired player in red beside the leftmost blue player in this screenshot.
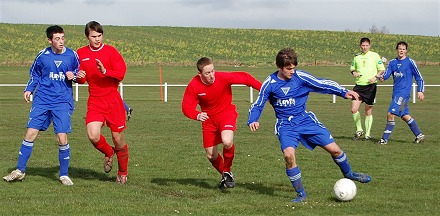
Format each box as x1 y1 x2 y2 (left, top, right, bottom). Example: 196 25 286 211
76 21 128 184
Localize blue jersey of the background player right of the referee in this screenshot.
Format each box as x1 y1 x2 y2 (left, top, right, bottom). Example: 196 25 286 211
383 57 425 98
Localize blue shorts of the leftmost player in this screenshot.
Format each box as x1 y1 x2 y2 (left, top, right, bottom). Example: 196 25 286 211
27 107 73 134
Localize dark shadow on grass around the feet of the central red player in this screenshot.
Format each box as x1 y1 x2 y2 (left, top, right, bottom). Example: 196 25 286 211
151 178 274 195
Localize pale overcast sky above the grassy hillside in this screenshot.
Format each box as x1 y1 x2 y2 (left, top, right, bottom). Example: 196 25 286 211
0 0 440 36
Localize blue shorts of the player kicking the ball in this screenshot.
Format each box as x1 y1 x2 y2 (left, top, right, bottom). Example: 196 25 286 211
275 112 335 151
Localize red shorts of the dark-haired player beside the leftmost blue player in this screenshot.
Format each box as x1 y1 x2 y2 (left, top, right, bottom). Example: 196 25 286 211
86 92 127 132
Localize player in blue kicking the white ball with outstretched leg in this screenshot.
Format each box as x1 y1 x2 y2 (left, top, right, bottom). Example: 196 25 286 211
247 48 371 202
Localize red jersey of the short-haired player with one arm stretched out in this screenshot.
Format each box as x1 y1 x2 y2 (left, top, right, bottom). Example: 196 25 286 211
182 72 261 120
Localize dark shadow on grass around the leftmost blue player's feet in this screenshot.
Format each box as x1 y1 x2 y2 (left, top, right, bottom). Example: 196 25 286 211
3 166 115 181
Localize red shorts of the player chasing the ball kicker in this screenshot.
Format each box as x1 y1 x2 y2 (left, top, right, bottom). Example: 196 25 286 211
202 107 238 148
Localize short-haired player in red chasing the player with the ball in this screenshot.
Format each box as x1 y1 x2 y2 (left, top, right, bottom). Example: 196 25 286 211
182 57 261 189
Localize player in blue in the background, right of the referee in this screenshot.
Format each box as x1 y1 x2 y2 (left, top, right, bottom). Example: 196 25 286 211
378 41 425 144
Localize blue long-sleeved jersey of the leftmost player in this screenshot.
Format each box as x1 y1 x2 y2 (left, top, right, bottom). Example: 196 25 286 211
25 47 79 110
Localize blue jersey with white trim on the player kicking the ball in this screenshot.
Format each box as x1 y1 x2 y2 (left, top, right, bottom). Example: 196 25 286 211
248 70 348 124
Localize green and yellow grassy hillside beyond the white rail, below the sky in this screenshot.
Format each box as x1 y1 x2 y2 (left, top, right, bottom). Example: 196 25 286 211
0 23 440 67
